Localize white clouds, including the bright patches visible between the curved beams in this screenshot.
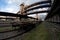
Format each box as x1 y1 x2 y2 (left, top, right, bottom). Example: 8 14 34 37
0 0 48 19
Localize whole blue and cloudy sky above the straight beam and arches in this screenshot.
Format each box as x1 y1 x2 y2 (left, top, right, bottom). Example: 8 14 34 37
0 0 46 19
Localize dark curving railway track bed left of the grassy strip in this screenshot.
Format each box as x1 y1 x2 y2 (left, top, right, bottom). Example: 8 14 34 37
0 20 35 40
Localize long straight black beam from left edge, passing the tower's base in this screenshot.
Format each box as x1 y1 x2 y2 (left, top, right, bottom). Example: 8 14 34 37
0 12 35 19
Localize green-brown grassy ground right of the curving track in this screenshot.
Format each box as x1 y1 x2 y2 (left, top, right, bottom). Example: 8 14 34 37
22 22 60 40
